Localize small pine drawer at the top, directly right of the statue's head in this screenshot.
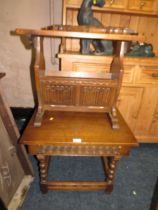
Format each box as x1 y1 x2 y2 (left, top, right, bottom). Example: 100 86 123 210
105 0 127 9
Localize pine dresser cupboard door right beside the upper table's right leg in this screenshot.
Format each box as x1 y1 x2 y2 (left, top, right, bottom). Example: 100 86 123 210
117 87 143 133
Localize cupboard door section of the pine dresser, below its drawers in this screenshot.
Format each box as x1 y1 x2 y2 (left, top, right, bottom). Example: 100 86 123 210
118 86 158 142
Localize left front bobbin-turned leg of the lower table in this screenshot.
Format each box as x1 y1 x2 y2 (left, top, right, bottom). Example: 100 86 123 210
37 155 49 193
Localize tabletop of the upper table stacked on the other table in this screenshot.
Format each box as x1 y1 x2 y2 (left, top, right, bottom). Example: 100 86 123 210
15 25 145 42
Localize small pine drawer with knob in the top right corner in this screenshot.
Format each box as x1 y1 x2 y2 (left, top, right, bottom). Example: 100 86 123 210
128 0 156 12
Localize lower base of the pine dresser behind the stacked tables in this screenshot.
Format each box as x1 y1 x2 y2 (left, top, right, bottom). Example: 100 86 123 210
58 54 158 142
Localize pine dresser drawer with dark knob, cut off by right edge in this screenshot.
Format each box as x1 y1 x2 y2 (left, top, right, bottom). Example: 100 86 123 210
135 66 158 84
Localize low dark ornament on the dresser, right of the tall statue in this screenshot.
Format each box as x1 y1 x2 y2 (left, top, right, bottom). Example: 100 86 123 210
126 42 155 57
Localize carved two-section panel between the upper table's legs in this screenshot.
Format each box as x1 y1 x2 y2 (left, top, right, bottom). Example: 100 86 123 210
41 77 118 111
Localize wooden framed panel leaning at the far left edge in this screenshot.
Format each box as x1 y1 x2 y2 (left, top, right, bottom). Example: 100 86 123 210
0 73 33 209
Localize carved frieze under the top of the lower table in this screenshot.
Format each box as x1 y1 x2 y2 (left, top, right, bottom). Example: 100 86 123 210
38 145 122 156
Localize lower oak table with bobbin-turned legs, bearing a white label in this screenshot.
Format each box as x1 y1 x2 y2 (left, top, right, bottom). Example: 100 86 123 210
20 111 138 193
